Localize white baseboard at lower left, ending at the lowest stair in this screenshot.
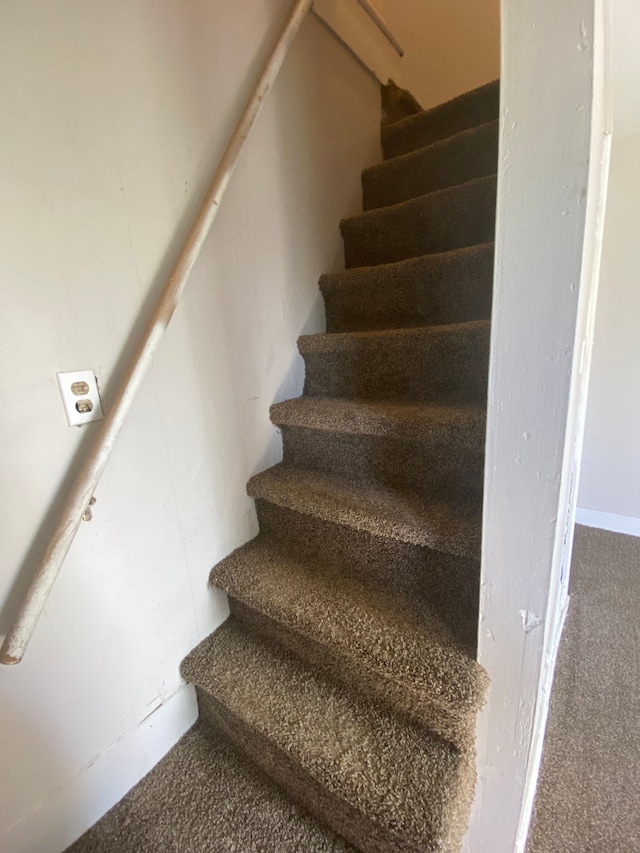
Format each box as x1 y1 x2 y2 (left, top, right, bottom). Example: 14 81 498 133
2 684 198 853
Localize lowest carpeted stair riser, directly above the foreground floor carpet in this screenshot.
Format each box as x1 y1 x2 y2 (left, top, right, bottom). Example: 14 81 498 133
196 686 416 853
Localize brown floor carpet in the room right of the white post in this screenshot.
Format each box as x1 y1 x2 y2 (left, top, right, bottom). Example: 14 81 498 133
527 527 640 853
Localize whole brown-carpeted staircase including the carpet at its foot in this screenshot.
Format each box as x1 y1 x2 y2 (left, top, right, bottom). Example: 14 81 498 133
71 82 499 853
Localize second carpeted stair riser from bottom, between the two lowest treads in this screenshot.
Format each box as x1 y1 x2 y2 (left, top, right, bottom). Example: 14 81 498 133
229 597 476 752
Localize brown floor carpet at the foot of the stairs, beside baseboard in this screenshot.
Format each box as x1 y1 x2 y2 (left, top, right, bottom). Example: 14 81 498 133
67 722 355 853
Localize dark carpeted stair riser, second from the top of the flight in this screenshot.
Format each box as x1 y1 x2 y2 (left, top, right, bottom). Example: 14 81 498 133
362 121 498 210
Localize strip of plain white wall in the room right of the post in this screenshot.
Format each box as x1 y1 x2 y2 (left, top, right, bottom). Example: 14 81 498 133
578 130 640 536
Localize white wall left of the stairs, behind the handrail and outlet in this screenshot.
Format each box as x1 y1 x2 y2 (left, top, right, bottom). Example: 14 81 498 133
0 0 379 853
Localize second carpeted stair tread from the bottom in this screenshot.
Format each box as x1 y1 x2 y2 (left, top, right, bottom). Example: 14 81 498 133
210 536 485 717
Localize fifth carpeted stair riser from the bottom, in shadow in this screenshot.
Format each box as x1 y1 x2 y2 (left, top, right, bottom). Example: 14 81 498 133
300 325 489 404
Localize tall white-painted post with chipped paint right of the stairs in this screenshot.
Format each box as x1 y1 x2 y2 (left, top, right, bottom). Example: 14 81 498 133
465 0 610 853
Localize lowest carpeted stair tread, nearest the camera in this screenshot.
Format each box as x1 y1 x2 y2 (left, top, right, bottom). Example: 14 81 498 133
182 618 473 851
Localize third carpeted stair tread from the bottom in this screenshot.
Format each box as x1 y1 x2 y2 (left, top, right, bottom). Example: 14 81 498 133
247 464 482 557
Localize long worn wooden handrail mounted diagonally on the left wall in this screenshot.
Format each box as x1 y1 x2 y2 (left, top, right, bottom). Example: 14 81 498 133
0 0 313 664
